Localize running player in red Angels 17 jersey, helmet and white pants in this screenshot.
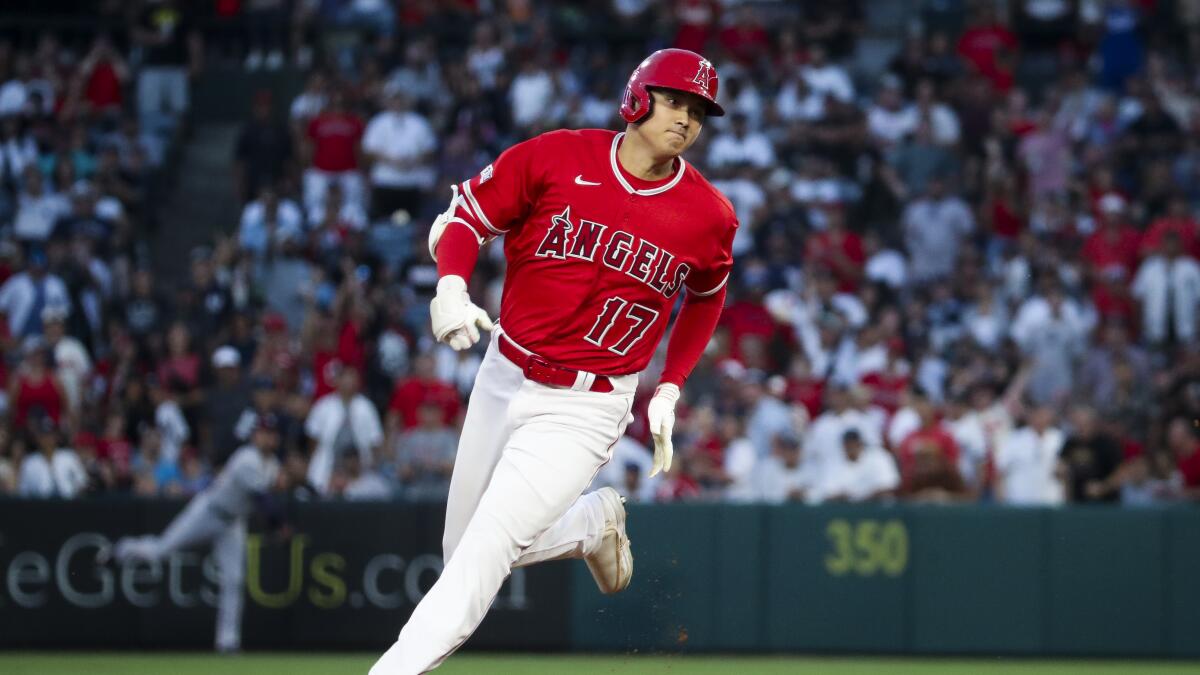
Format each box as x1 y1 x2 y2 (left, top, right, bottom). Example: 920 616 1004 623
371 49 737 675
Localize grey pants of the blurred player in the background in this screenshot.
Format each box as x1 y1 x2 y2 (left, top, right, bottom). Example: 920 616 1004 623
115 494 246 651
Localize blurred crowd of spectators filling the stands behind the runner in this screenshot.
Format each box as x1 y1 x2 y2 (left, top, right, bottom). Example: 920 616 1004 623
0 0 1200 504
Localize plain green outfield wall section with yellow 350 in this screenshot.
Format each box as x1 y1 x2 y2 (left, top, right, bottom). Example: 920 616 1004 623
571 506 1200 657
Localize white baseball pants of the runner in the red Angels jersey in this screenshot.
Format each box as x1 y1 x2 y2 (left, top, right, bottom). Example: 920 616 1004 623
371 329 637 675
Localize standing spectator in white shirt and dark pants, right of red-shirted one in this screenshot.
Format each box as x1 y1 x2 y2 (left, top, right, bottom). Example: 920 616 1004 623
362 90 438 220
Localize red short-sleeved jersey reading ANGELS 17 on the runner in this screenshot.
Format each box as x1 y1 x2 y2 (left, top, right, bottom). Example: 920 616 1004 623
457 130 738 375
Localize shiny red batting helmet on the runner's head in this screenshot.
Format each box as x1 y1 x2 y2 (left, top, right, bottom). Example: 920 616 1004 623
620 49 725 124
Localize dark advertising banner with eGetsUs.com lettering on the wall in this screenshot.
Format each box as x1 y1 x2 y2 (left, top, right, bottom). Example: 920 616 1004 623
0 500 569 650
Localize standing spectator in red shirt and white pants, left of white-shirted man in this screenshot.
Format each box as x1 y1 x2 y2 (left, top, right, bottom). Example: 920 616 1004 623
304 91 366 213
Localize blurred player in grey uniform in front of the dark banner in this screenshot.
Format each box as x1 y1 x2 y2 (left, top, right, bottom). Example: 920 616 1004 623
101 414 280 652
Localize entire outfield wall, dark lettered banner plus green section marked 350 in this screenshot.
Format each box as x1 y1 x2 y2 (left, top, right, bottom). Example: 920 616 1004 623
0 500 1200 657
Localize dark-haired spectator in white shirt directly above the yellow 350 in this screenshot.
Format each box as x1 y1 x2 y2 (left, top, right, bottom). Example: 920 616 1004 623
809 429 900 503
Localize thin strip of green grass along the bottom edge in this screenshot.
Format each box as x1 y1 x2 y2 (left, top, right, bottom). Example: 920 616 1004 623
0 652 1200 675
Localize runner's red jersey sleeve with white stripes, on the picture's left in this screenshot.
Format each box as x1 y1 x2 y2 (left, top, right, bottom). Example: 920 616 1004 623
455 136 552 240
